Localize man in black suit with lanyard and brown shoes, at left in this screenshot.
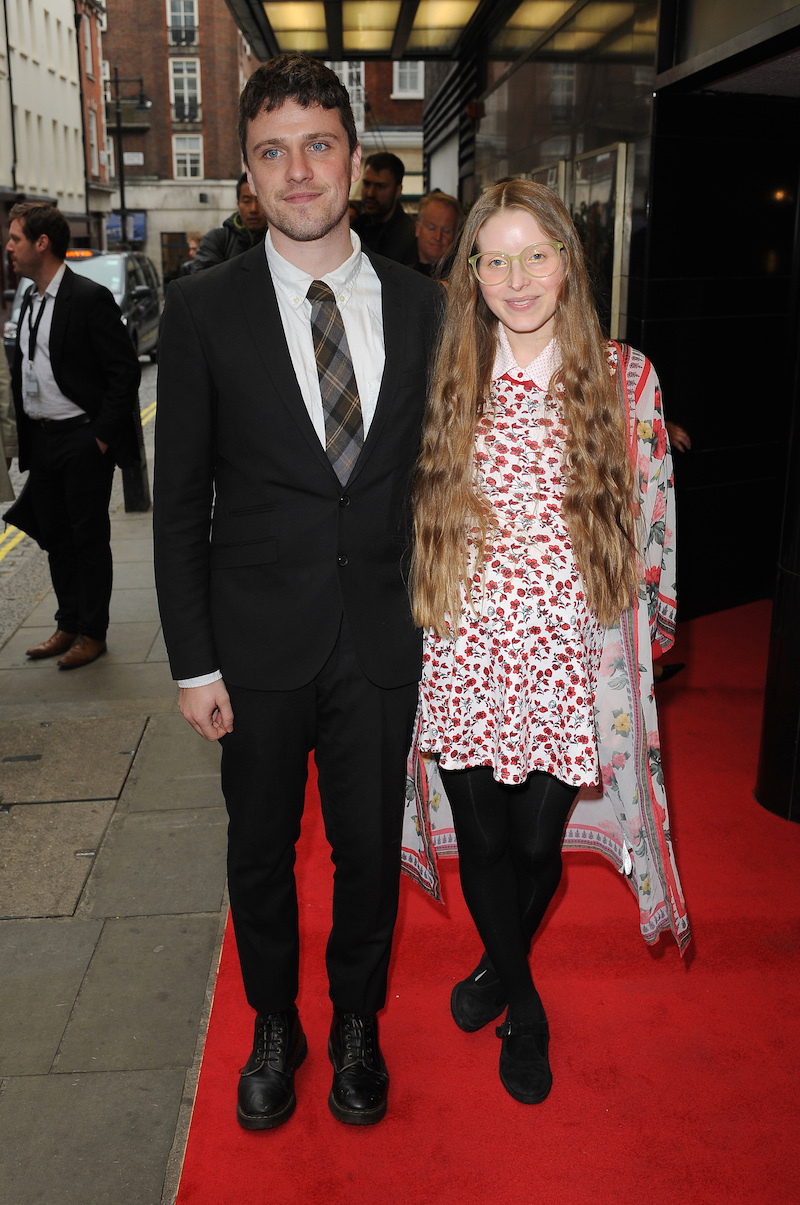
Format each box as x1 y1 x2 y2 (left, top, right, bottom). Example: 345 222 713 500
6 201 141 670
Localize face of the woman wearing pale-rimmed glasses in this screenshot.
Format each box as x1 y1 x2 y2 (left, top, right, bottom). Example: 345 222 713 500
477 210 566 368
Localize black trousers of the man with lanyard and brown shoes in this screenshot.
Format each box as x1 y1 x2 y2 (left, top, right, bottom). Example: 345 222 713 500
30 419 114 640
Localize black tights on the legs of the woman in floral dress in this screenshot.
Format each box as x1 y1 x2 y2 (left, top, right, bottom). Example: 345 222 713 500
441 765 577 1019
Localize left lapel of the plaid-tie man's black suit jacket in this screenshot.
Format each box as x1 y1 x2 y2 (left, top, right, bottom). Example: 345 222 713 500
232 245 335 476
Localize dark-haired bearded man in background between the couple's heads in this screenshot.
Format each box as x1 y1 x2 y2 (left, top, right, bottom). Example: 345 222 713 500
353 151 417 268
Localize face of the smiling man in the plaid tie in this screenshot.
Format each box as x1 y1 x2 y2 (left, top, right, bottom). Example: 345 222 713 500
247 100 361 242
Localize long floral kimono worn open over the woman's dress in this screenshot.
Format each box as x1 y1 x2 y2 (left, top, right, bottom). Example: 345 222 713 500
402 343 690 951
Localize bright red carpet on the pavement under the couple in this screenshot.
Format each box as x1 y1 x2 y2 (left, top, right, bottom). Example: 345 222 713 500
177 603 800 1205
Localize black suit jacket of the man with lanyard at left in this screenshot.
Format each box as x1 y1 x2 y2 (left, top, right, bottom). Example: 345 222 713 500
12 268 141 469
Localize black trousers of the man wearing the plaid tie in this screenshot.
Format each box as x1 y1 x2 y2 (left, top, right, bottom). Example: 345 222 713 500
220 623 417 1013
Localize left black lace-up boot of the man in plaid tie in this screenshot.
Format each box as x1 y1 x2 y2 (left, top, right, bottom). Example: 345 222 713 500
236 1009 308 1129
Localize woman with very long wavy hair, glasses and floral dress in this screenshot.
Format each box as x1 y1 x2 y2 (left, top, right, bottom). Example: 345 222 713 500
412 180 688 1104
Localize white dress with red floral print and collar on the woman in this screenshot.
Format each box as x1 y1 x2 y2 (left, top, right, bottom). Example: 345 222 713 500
419 327 602 787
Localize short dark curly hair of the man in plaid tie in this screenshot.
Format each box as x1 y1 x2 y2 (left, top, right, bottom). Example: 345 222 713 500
239 53 358 163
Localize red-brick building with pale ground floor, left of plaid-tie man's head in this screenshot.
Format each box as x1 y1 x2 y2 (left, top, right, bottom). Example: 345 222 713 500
104 0 258 277
